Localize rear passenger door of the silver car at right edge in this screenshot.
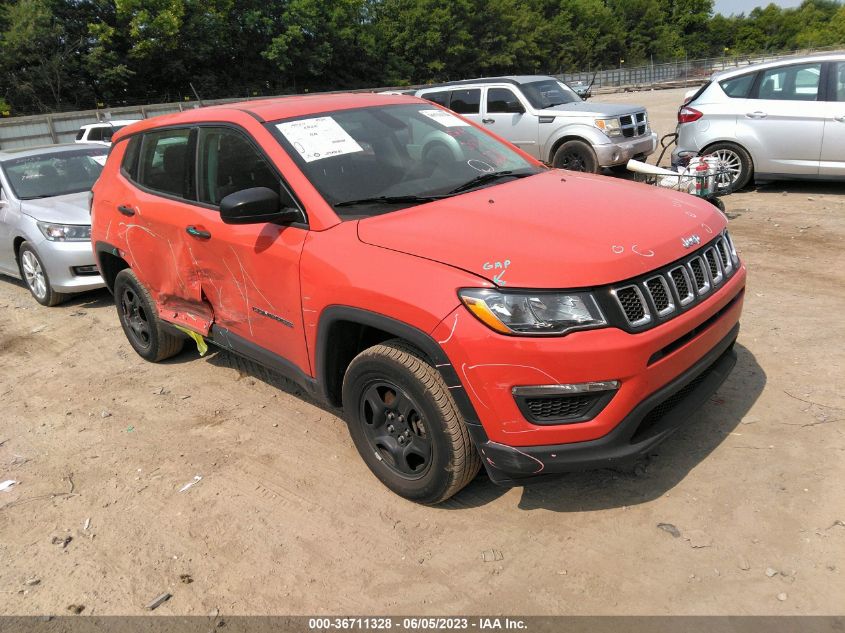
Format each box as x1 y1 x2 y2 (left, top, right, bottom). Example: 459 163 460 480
737 62 827 175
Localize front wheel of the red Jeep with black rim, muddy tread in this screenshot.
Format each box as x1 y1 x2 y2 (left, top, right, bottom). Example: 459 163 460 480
343 339 481 504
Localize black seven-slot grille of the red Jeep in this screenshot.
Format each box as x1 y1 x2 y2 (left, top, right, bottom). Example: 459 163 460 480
611 232 736 327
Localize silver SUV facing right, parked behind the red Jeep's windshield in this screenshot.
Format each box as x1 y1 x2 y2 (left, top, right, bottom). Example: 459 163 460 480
416 75 657 172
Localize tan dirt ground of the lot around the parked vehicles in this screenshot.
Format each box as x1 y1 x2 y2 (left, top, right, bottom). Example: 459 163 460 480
0 86 845 615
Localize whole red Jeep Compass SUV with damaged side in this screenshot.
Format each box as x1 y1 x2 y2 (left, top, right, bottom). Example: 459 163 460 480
92 94 745 503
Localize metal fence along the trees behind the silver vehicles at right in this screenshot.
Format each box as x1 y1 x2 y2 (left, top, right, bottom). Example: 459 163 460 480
556 47 841 91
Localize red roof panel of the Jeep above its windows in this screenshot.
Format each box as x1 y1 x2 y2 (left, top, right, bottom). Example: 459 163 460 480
112 92 422 142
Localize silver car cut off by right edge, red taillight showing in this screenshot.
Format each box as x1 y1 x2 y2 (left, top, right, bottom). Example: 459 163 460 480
673 53 845 191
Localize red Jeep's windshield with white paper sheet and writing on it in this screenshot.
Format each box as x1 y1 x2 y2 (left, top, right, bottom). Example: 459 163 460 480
269 104 544 219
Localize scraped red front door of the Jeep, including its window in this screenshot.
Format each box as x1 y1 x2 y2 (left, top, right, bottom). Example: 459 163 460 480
188 126 309 372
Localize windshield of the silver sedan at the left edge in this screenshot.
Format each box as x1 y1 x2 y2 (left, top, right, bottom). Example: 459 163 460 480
2 147 108 200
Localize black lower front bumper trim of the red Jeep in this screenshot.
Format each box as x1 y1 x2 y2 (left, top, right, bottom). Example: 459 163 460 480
470 324 739 485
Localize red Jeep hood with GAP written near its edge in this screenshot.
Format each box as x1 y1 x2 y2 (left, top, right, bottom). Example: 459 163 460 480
358 170 727 288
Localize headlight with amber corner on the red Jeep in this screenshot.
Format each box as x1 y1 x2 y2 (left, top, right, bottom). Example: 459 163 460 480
458 288 607 336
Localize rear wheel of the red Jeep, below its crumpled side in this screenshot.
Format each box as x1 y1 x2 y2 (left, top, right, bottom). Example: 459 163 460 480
114 268 185 363
